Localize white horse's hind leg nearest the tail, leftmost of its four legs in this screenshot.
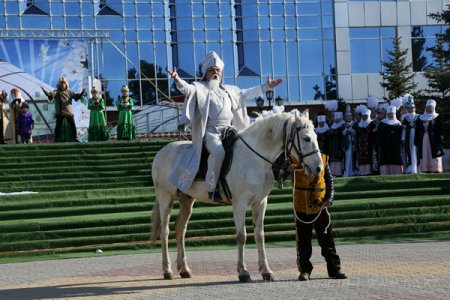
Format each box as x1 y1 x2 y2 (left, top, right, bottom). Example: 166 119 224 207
156 190 173 279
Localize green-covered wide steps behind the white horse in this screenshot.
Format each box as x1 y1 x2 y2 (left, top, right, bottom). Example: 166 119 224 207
0 140 450 262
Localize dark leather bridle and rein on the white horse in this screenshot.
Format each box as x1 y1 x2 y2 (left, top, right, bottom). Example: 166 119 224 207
238 120 319 166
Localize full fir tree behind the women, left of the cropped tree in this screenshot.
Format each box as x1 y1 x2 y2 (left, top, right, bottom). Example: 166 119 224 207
380 36 417 99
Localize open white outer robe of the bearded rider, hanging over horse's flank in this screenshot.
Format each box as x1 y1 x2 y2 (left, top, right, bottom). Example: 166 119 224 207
169 79 269 193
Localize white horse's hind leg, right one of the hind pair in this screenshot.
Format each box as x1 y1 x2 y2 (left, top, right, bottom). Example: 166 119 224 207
176 193 195 278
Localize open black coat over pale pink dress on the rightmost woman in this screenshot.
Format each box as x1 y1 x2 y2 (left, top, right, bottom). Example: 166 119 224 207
414 115 444 159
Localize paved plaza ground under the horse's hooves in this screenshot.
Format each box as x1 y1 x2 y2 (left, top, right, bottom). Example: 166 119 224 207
0 241 450 300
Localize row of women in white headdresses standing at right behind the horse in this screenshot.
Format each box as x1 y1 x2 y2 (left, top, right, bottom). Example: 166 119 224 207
316 94 444 177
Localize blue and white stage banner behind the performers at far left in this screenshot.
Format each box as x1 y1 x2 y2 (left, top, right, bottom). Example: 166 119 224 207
0 39 89 139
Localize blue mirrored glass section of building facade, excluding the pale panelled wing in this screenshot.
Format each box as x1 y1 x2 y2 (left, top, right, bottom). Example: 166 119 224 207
0 0 336 105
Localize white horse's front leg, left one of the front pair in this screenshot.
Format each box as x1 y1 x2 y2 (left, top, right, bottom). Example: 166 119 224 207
233 201 251 282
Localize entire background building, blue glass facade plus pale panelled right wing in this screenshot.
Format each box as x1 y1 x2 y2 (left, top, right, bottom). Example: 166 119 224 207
0 0 450 105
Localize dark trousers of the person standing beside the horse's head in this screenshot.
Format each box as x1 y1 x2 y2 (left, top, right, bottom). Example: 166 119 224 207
295 209 341 276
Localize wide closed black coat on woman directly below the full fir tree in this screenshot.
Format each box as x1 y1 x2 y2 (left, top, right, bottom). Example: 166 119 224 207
377 122 403 166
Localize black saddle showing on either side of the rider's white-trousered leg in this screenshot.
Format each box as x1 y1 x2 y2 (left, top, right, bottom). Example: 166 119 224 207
194 127 238 199
